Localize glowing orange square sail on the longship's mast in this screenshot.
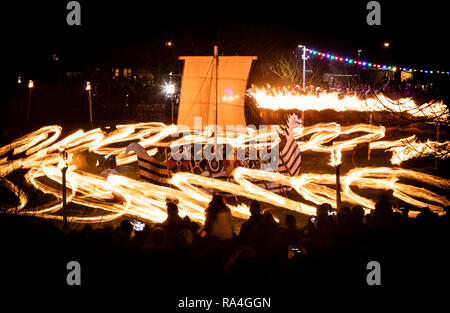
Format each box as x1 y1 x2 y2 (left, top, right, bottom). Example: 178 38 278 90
177 56 257 130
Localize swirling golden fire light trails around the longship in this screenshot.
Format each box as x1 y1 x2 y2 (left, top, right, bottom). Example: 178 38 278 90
0 89 450 223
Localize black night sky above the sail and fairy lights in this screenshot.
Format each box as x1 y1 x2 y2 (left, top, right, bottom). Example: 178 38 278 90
1 0 450 74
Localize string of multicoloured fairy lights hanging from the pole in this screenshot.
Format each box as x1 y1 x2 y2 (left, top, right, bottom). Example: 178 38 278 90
306 48 450 75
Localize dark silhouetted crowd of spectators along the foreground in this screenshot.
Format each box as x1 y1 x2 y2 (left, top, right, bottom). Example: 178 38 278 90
0 190 450 289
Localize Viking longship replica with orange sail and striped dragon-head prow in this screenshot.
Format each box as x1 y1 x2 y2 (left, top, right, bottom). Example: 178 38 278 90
126 46 302 196
